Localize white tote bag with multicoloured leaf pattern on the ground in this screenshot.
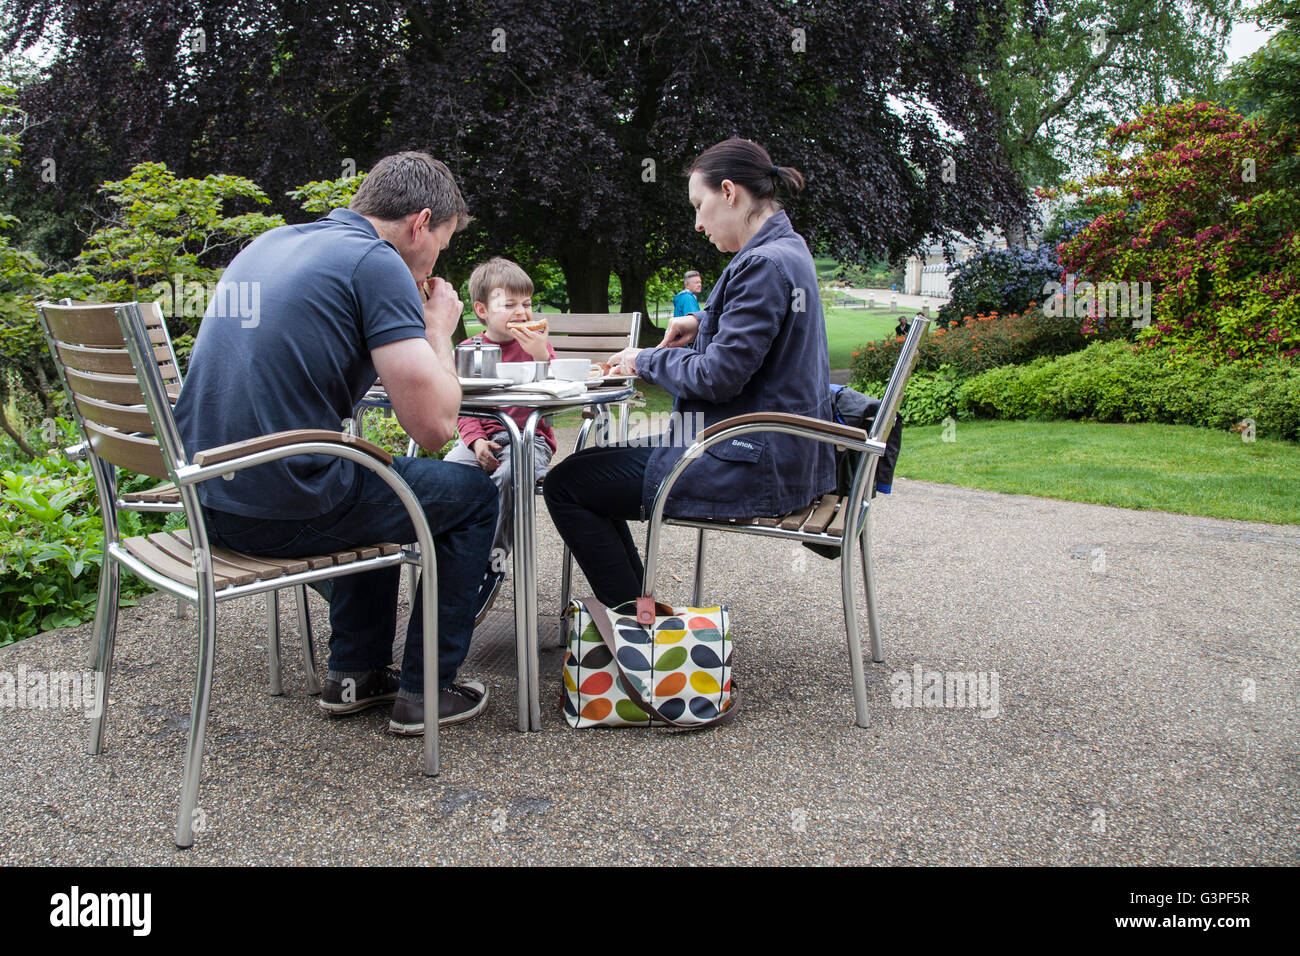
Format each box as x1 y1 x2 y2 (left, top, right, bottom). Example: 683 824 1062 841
563 597 740 728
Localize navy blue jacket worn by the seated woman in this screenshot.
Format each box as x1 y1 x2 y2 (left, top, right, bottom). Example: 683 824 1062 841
637 212 835 518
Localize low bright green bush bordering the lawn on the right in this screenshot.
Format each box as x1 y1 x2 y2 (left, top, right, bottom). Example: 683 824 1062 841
958 342 1300 440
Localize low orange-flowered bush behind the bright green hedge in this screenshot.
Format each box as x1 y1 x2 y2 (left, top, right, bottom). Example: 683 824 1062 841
850 303 1123 390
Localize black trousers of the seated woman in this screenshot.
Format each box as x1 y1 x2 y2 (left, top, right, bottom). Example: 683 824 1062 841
542 446 654 607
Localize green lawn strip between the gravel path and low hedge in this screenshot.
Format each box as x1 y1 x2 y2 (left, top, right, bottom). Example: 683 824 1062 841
897 421 1300 524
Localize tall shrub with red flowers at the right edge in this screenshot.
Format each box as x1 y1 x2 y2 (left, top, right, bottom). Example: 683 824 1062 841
1058 103 1300 362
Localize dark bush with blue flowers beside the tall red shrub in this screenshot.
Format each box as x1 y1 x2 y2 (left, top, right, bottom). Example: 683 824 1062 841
937 243 1061 328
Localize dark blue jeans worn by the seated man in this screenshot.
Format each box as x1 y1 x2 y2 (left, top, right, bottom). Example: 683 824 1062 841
207 458 497 693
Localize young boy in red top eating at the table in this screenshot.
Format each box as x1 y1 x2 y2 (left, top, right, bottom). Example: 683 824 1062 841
447 258 555 618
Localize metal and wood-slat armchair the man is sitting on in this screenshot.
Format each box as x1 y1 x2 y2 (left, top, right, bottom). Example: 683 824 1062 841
36 302 439 848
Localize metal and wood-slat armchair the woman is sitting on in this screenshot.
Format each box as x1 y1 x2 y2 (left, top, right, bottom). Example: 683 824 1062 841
642 316 930 727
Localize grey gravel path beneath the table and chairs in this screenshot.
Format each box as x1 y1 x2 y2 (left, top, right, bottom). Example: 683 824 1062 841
0 434 1300 865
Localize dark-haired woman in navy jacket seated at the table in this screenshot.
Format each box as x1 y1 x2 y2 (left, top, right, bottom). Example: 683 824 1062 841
545 139 835 607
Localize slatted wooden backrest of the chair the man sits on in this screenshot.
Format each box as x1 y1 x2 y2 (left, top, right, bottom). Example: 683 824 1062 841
36 302 183 479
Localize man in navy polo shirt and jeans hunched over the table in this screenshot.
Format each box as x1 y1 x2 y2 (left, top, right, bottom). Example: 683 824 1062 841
176 152 497 734
